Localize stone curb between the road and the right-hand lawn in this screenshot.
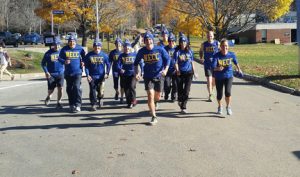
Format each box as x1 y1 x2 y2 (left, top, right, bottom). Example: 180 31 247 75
195 59 300 96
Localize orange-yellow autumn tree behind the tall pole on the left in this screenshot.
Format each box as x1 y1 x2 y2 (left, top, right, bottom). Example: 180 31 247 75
36 0 137 46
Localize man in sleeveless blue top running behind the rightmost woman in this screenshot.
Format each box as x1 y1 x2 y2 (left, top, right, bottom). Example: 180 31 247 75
199 31 220 102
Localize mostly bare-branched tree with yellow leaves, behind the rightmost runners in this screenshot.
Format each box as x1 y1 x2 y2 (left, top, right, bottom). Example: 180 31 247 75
168 0 292 39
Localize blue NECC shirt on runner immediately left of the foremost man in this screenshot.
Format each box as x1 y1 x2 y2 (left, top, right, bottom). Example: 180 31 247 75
118 52 136 76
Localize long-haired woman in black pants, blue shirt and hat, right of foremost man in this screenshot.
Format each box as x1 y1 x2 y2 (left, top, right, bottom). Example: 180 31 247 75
174 35 195 114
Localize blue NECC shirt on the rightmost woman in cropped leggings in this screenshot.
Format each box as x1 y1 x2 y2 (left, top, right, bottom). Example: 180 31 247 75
212 52 238 80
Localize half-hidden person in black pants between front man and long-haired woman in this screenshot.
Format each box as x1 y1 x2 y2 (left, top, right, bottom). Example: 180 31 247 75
164 33 177 102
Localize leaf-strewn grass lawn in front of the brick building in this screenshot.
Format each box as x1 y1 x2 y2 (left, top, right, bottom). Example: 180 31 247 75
191 38 300 90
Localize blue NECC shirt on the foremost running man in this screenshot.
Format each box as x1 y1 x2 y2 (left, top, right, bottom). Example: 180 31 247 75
134 46 170 79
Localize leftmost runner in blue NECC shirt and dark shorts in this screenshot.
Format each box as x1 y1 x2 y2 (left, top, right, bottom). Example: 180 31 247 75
41 37 64 109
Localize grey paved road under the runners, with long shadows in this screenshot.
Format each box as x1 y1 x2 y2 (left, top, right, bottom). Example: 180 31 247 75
0 64 300 177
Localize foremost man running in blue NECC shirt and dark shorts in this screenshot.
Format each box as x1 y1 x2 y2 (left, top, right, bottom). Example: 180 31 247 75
134 32 170 125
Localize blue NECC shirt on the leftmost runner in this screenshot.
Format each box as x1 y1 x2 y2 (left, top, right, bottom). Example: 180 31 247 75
41 49 65 76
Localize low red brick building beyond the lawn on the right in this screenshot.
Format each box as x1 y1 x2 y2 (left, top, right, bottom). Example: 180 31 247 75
229 23 297 44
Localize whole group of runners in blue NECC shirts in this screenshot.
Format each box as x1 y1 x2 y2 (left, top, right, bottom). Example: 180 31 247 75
41 29 242 125
